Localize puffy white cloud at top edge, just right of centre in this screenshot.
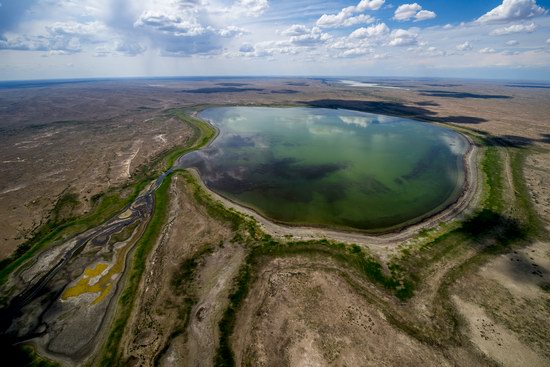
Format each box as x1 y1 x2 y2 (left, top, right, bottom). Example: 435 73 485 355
316 0 385 28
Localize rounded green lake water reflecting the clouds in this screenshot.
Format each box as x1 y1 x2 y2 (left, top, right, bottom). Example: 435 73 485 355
179 107 468 232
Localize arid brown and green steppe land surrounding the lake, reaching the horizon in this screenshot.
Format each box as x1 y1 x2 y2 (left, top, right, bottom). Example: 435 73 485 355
0 78 550 366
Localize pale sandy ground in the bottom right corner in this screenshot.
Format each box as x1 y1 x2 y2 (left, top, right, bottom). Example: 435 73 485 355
453 242 550 366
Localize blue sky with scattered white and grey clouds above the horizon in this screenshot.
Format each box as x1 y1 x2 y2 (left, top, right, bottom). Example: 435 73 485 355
0 0 550 80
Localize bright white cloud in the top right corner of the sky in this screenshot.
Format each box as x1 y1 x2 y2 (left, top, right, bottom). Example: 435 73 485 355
477 0 546 23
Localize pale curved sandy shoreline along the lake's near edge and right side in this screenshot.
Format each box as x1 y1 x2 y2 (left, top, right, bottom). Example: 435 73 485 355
188 134 480 256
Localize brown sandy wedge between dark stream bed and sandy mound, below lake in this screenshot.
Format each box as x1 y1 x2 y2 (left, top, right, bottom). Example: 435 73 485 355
123 175 244 366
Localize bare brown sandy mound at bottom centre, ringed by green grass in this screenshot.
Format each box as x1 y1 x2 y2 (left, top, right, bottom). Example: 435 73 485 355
232 257 452 366
